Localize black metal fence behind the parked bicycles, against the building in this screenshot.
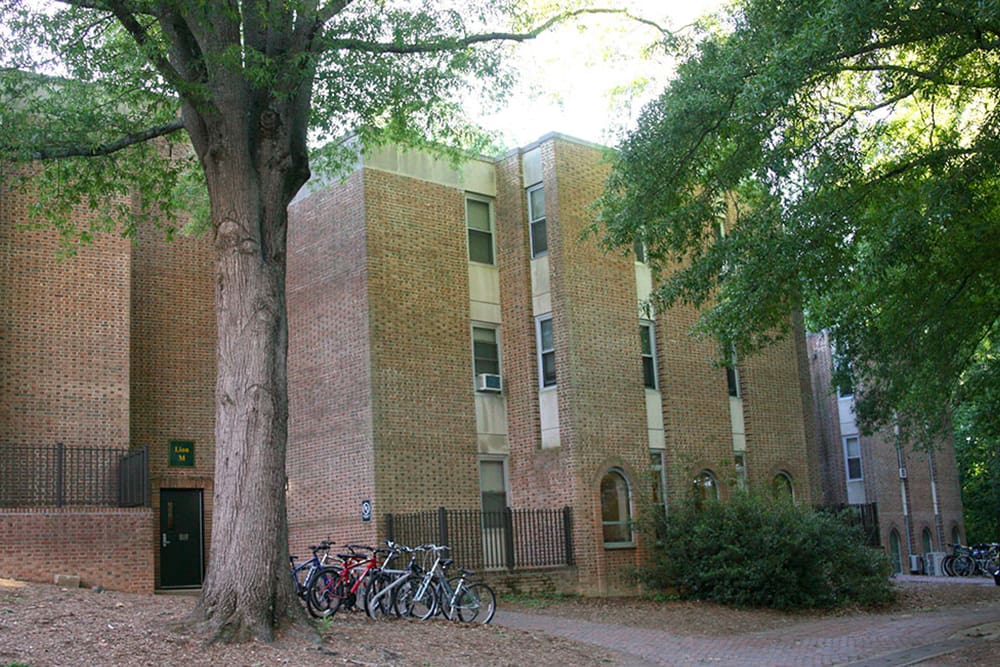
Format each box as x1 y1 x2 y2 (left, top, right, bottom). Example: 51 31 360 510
385 507 573 570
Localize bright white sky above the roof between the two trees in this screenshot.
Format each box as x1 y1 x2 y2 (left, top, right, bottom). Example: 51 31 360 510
470 0 722 148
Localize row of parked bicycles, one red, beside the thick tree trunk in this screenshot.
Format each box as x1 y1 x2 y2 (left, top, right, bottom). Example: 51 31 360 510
291 541 496 623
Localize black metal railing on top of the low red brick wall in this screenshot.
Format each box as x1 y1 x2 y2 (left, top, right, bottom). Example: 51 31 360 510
0 443 150 507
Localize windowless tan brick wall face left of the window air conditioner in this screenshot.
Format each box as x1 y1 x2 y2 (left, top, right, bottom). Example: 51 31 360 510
365 170 480 516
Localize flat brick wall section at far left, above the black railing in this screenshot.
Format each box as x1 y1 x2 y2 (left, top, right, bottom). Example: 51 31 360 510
0 183 130 447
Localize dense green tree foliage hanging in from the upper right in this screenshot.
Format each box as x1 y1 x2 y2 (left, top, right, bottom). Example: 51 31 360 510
600 0 1000 440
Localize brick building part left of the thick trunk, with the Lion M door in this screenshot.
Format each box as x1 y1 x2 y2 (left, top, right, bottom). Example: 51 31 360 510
0 174 215 591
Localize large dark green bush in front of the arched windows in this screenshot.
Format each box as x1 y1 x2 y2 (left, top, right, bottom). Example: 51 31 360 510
642 494 892 609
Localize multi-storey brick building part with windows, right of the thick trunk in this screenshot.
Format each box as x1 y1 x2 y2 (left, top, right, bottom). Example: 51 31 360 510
288 135 818 591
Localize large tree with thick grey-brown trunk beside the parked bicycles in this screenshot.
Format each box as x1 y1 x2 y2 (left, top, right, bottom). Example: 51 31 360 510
0 0 664 640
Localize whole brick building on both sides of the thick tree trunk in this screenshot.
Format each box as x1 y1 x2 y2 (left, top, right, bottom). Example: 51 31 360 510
0 135 823 592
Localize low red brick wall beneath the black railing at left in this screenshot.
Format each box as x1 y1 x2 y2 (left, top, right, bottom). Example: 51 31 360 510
0 508 156 593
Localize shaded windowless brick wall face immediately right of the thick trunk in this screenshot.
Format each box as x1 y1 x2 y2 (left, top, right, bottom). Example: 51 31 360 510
286 171 381 558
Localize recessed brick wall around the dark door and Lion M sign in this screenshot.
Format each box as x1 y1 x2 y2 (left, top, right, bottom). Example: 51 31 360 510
130 217 216 585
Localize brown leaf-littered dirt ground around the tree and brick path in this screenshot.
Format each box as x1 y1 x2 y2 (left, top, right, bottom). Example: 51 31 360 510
0 579 1000 667
